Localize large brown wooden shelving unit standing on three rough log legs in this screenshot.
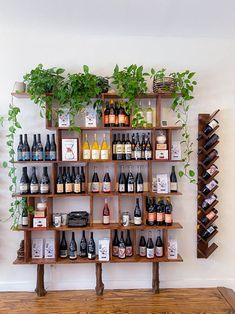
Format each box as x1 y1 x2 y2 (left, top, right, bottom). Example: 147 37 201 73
12 93 183 296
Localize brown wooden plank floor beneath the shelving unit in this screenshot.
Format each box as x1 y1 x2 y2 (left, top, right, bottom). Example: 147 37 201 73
0 288 235 314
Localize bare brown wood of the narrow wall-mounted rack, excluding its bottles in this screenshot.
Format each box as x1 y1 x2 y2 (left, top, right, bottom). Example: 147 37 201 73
197 110 219 258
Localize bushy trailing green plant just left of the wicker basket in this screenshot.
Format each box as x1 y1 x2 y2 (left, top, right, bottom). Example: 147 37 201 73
111 64 149 127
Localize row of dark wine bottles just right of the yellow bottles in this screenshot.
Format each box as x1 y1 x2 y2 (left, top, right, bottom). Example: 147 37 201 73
112 133 153 160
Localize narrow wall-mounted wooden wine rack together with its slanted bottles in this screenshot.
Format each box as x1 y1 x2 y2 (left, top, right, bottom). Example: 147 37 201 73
197 109 220 258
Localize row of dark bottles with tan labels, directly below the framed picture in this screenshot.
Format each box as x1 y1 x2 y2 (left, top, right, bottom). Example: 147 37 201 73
56 166 86 194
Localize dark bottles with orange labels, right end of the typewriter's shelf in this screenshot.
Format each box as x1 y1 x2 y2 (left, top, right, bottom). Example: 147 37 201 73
146 197 173 226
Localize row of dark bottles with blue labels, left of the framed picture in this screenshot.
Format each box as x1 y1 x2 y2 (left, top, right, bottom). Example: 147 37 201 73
17 134 56 161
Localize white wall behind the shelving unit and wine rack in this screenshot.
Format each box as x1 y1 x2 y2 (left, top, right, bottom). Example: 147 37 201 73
0 30 235 290
